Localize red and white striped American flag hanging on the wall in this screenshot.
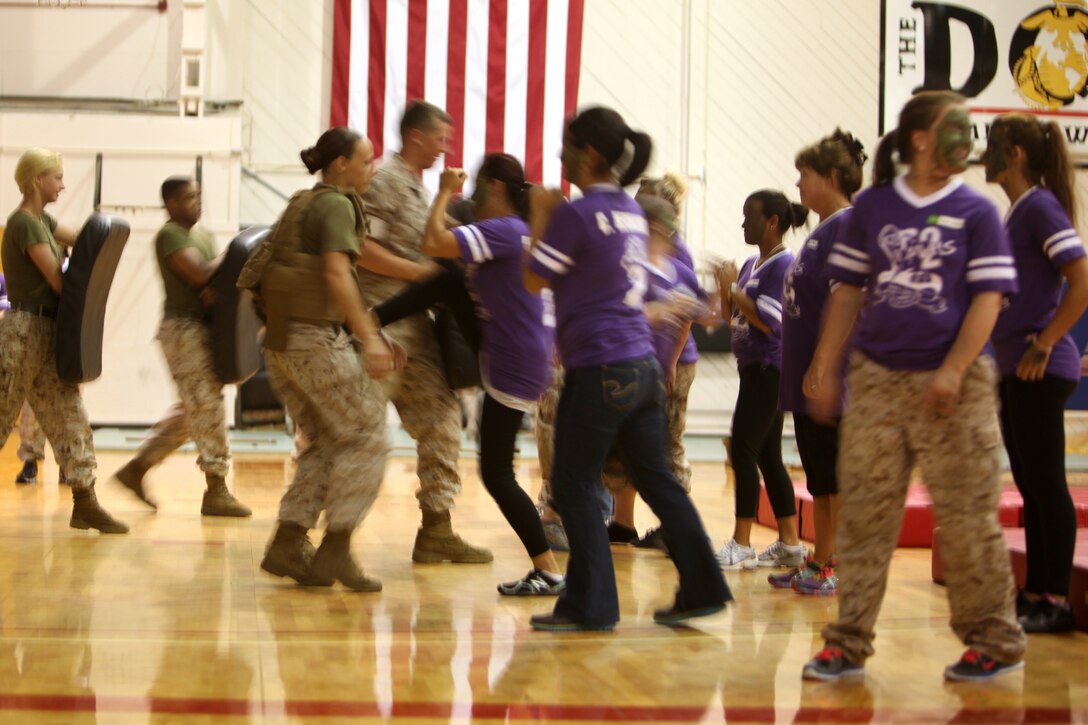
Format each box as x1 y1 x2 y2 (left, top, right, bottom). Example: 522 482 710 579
330 0 584 189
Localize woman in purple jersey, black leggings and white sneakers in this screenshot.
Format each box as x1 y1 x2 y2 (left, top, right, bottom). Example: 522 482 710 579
717 189 808 570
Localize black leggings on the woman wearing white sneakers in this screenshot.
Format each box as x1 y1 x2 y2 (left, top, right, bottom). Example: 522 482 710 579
729 365 798 518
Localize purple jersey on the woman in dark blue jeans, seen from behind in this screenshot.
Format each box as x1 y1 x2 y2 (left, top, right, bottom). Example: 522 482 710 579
529 184 654 369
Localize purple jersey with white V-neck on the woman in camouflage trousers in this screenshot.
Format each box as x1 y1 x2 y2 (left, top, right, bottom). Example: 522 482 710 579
827 176 1016 370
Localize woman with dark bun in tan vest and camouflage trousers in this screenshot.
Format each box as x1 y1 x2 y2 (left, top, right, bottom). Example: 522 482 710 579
257 126 405 591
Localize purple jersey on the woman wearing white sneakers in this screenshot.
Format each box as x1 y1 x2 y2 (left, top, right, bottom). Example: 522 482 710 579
729 248 793 370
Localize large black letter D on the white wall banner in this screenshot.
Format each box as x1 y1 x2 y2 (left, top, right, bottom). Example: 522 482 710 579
911 2 998 98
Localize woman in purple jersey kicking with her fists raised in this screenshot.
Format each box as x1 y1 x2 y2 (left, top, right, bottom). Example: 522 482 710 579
422 153 565 595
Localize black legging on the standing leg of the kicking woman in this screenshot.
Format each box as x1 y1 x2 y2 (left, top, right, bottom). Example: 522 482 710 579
480 394 548 557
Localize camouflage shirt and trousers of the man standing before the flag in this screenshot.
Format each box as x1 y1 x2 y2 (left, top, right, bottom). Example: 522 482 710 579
359 156 461 513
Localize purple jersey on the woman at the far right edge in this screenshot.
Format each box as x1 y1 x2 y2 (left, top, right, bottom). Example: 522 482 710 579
993 186 1085 380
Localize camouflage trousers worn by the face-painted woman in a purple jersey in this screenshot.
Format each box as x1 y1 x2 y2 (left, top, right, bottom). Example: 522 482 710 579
824 353 1025 663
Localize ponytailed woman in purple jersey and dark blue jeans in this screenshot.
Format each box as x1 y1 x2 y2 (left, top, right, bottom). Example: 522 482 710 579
523 107 732 631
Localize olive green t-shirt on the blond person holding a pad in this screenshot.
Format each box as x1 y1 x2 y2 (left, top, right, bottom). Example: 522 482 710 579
2 209 61 309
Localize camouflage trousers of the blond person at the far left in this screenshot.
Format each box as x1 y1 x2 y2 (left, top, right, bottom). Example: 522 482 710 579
0 310 97 489
